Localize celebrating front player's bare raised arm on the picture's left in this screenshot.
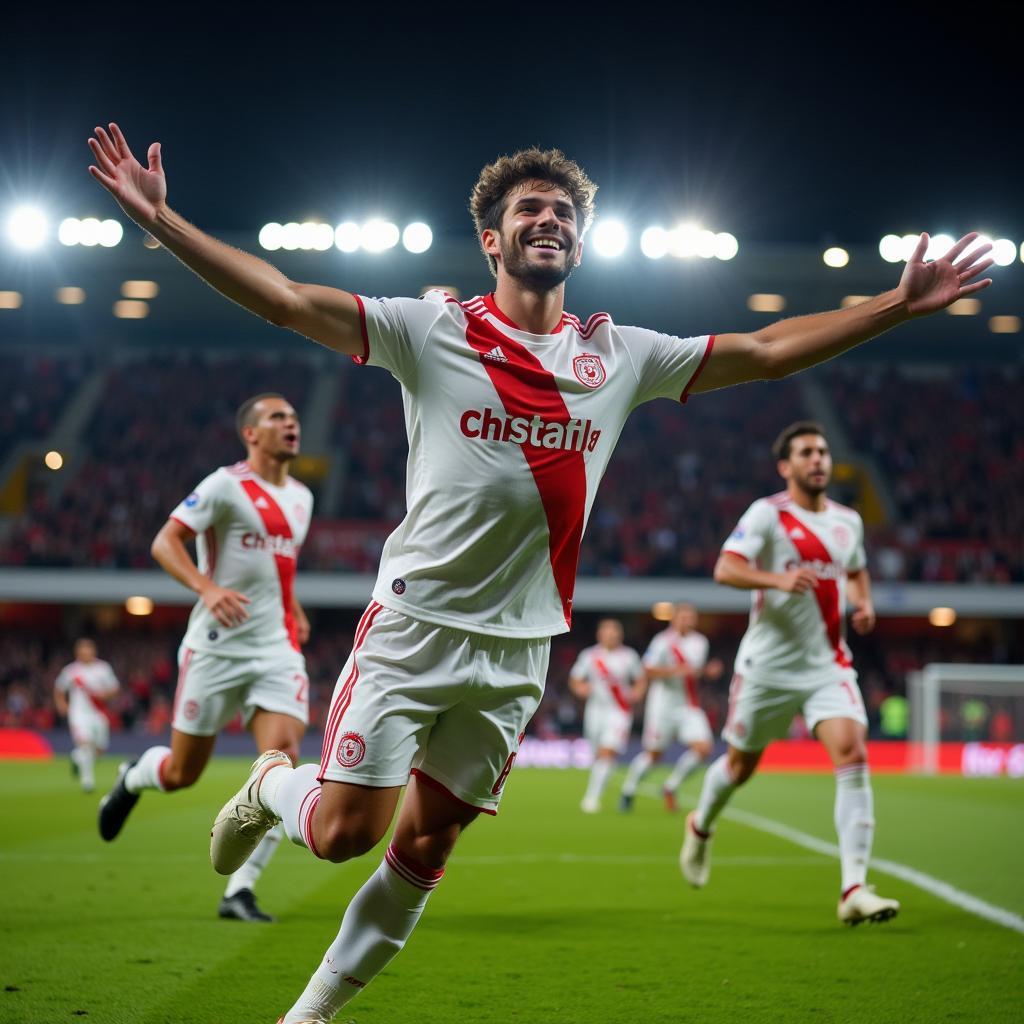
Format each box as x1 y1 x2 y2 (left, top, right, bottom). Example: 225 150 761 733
89 123 362 355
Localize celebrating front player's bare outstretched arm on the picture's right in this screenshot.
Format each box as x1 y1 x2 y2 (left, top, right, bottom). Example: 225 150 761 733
693 231 993 391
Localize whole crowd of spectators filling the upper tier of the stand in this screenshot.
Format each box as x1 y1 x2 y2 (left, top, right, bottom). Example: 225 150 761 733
0 353 1024 582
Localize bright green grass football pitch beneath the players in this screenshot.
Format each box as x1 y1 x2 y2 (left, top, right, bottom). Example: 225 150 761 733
0 759 1024 1024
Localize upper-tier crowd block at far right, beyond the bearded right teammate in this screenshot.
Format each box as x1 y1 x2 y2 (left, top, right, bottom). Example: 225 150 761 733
820 364 1024 583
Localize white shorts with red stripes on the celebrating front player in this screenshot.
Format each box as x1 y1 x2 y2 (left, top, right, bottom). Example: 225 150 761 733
318 601 551 814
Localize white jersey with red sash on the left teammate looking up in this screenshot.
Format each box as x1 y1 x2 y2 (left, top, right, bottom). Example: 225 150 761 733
171 462 313 657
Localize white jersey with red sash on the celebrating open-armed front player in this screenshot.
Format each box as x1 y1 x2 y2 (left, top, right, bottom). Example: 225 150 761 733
355 291 714 637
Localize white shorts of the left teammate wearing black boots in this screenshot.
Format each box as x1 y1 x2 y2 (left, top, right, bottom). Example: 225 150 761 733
171 644 309 736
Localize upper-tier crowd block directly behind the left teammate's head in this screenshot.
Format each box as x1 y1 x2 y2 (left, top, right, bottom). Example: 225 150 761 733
0 354 312 568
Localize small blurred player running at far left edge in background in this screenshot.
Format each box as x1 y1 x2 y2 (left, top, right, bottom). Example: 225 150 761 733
53 637 121 793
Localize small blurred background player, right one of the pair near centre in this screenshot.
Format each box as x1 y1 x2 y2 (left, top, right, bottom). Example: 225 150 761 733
618 604 722 811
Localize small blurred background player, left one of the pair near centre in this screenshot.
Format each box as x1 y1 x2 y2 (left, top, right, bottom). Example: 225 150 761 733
569 618 644 814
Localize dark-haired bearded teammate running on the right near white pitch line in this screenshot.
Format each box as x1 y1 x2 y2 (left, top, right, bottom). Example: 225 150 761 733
680 421 899 925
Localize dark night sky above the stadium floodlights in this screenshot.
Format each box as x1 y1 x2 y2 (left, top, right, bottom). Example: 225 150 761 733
0 9 1024 245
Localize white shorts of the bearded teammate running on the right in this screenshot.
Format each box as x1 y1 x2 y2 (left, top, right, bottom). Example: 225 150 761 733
722 669 867 752
